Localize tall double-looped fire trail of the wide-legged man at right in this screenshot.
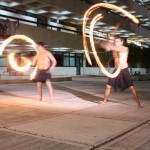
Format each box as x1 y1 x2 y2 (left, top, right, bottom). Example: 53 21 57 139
82 3 139 78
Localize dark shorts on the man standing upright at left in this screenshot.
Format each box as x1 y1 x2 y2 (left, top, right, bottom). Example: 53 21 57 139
34 69 51 82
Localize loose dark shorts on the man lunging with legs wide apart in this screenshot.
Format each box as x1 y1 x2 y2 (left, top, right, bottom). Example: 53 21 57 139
107 68 133 90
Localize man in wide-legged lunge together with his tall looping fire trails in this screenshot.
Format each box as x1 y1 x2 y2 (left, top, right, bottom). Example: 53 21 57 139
82 3 141 108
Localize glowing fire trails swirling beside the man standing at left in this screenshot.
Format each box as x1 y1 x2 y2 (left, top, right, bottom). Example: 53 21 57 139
0 34 37 79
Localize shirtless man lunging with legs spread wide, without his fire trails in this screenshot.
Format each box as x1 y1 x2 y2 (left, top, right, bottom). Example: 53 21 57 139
102 36 141 108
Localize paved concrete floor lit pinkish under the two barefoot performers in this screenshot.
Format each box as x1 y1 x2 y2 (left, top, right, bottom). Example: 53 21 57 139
0 76 150 150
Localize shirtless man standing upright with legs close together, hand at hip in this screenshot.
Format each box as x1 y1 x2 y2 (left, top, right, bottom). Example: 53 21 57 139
31 42 57 101
